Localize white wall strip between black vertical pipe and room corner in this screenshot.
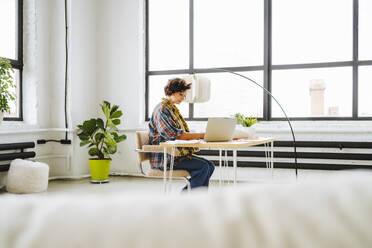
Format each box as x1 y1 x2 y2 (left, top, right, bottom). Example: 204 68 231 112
69 0 98 175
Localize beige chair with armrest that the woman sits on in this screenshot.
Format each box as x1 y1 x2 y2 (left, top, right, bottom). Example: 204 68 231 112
136 131 191 192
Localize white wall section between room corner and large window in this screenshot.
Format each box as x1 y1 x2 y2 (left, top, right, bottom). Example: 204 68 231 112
96 0 144 173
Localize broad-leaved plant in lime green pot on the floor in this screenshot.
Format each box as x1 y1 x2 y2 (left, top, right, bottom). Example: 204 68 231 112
77 101 127 183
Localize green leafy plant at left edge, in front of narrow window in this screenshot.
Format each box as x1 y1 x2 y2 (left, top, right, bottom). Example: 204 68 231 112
0 57 16 124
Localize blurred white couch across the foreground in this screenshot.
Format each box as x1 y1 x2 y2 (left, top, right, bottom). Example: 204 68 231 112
0 172 372 248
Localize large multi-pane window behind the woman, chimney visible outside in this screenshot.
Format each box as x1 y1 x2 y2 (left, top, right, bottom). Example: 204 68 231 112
146 0 372 120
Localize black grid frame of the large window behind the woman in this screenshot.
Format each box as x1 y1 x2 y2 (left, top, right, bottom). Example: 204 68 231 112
145 0 372 121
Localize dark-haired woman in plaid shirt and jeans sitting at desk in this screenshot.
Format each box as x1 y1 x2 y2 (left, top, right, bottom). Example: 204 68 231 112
149 78 214 189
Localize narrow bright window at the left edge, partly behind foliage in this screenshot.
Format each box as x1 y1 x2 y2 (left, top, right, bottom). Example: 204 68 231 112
0 0 23 120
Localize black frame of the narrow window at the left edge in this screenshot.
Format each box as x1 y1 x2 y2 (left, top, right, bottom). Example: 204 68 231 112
4 0 23 121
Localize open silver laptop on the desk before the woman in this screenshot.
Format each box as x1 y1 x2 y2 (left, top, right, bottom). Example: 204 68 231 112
204 118 236 142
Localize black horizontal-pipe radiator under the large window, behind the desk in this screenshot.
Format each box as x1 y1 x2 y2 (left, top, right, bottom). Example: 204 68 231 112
197 141 372 170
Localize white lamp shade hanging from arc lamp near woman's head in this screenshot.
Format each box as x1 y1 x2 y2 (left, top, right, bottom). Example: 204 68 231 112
184 74 211 103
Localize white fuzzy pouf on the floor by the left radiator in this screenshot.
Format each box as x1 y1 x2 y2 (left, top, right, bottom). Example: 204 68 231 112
6 159 49 194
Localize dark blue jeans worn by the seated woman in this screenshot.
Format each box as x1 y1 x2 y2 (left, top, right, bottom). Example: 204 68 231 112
174 156 214 189
